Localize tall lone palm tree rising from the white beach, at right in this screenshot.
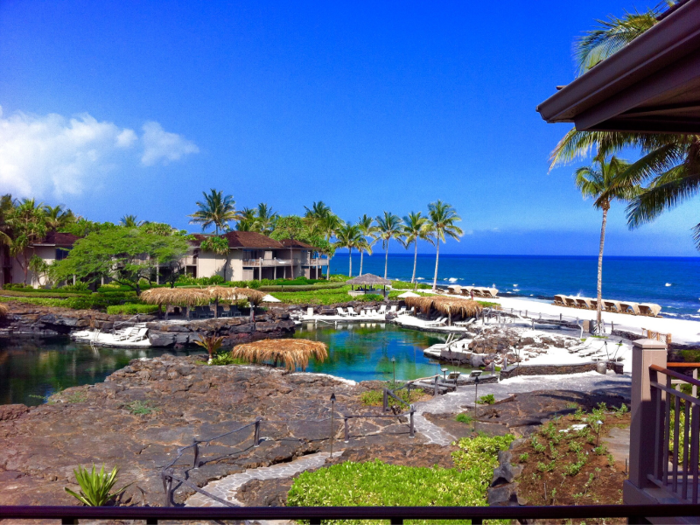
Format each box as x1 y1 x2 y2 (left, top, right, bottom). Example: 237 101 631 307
576 156 640 334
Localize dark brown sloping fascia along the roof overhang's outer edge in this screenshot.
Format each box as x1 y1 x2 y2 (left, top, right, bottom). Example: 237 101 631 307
537 0 700 130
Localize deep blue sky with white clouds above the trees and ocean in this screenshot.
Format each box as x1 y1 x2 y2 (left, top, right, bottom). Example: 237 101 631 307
0 0 699 256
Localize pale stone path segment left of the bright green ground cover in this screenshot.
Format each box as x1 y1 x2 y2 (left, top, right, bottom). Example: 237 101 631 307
185 451 330 507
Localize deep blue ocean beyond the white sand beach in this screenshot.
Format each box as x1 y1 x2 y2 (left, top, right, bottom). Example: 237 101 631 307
331 250 700 320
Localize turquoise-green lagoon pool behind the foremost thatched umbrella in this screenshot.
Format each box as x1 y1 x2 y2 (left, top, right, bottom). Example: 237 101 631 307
294 323 469 381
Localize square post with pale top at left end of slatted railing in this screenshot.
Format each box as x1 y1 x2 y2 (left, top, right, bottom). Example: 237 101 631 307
623 339 667 504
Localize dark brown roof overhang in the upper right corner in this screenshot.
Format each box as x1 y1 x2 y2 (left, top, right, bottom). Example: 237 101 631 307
537 0 700 134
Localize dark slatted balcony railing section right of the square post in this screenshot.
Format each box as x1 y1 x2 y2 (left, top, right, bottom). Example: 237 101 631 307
648 365 700 504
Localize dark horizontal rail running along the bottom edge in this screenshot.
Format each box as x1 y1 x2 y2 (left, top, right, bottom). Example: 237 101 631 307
0 504 700 525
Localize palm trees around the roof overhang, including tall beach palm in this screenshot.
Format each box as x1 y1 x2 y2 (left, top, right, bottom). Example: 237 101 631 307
550 7 700 326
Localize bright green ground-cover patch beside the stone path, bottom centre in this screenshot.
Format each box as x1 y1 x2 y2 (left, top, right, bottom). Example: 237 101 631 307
287 436 514 525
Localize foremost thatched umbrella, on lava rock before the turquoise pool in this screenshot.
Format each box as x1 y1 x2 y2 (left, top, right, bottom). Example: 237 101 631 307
231 339 328 372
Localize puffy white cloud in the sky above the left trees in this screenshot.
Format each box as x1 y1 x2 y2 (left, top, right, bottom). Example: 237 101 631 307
0 107 199 198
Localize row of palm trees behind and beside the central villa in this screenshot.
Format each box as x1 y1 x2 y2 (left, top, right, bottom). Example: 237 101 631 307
189 189 463 289
